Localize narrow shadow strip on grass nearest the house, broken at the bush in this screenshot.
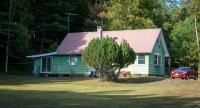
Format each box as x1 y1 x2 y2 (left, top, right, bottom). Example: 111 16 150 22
0 74 165 85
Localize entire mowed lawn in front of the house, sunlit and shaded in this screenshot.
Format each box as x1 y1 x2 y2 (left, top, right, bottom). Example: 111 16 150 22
0 74 200 108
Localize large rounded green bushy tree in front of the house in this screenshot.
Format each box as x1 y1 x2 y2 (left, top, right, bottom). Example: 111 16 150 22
82 37 136 80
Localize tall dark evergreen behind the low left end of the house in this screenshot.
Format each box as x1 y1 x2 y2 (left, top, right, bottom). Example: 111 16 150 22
32 0 77 53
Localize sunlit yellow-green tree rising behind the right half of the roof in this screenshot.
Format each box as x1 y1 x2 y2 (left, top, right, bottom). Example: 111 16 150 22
106 0 156 30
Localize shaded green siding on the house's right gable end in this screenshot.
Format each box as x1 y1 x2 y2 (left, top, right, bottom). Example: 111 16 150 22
149 40 165 75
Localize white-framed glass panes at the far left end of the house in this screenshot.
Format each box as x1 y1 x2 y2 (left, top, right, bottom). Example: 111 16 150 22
42 57 52 72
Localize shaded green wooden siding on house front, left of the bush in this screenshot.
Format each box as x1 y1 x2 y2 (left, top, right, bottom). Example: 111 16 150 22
34 55 88 74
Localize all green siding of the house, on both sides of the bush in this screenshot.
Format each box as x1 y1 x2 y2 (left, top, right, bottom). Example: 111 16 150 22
34 44 165 75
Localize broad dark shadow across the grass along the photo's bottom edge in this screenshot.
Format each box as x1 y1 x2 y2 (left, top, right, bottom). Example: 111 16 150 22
0 89 200 108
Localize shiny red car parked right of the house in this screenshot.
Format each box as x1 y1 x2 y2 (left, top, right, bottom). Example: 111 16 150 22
171 67 198 80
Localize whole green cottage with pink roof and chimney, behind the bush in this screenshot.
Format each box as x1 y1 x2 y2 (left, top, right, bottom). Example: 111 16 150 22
26 27 169 77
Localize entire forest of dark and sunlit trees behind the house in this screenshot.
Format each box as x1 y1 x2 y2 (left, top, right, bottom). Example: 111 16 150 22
0 0 200 70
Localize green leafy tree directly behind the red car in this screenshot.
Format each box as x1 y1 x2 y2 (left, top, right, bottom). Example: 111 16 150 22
170 16 198 66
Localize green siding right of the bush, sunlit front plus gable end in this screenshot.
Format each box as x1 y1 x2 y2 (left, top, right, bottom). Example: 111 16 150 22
121 35 165 75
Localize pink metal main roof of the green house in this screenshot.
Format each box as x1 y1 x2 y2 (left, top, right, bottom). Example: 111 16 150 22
56 29 161 55
